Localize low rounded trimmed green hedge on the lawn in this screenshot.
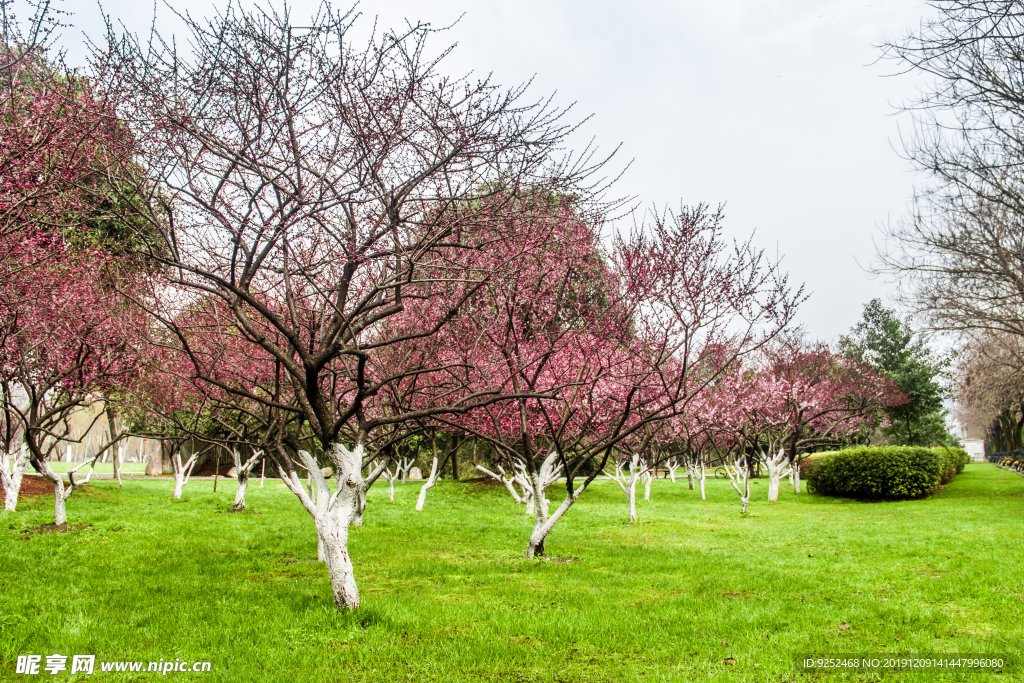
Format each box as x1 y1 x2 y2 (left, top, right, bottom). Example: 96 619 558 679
801 446 968 500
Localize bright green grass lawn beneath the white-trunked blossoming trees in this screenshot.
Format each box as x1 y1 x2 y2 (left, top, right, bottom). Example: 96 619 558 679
0 464 1024 683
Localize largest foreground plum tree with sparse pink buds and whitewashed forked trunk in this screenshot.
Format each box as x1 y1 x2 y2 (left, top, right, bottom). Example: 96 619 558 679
99 4 614 609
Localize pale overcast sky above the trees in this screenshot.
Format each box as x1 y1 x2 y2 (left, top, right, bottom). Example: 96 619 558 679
61 0 927 340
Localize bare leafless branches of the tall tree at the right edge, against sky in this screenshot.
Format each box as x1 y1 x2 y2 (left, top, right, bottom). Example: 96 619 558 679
881 0 1024 336
